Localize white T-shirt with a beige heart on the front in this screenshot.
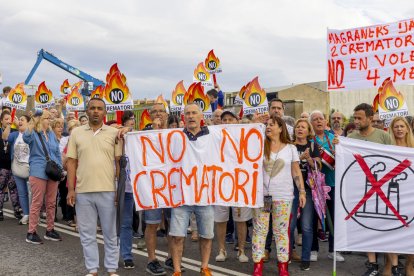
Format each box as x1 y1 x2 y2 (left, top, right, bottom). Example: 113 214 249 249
263 144 299 200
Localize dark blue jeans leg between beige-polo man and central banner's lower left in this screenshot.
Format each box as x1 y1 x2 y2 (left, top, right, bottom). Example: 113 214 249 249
119 193 134 261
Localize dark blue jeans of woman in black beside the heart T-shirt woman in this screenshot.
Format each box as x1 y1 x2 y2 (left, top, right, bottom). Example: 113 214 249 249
290 185 314 261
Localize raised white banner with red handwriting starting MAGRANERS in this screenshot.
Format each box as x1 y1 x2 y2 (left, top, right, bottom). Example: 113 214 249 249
327 19 414 91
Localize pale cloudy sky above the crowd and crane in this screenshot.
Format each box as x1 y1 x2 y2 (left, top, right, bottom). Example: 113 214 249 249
0 0 414 99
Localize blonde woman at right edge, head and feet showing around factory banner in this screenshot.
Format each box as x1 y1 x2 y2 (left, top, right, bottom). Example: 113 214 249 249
384 117 414 276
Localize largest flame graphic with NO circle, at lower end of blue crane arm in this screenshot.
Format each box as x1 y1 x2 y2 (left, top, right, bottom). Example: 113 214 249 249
104 67 129 104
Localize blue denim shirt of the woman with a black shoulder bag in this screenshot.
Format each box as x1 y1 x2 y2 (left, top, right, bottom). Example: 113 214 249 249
23 130 62 180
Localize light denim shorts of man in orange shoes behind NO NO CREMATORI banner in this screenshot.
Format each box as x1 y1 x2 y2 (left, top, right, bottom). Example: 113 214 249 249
169 205 214 240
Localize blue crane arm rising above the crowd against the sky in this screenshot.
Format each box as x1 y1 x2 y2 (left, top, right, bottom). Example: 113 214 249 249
24 49 105 96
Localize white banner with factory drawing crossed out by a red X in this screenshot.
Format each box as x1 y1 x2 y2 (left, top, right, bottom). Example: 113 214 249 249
334 137 414 254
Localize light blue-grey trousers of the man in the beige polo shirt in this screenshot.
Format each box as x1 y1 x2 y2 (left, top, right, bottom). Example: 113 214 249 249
75 192 119 273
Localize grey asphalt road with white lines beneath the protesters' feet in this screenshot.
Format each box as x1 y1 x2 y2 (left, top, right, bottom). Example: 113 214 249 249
0 203 366 276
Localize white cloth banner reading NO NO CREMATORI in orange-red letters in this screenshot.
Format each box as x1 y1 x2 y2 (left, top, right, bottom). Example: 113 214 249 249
125 124 264 210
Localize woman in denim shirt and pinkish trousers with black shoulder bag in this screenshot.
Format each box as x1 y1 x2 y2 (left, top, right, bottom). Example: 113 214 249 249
23 110 62 244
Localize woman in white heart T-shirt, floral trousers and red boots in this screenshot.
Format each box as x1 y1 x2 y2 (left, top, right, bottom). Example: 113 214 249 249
252 115 306 276
